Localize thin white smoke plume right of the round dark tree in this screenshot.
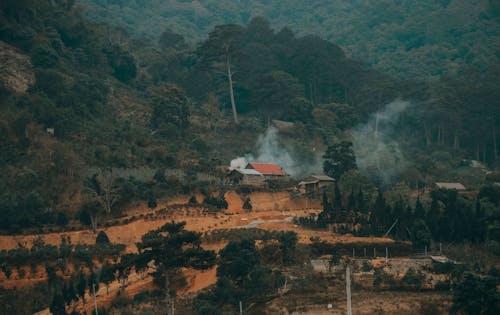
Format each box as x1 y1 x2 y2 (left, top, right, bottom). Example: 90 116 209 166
352 99 410 185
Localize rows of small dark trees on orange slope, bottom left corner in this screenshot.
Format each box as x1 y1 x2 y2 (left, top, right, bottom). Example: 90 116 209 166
0 231 125 315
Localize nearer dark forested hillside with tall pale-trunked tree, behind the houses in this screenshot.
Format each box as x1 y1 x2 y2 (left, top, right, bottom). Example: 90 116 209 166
0 1 500 232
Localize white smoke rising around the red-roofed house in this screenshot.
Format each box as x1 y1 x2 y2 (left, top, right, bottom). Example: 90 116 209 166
229 126 321 177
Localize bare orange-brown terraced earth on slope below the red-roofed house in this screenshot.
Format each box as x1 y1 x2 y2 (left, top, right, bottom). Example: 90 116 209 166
0 192 392 314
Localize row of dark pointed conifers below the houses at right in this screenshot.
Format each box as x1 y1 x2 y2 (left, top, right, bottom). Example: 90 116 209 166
297 185 500 253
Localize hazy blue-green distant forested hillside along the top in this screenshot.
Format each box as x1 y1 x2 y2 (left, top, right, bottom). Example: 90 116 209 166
78 0 500 78
